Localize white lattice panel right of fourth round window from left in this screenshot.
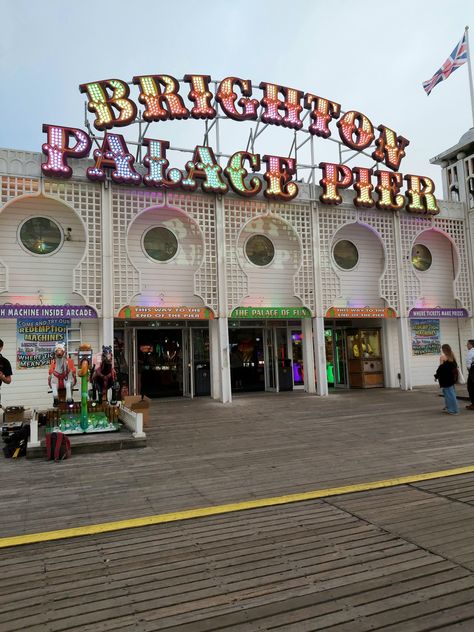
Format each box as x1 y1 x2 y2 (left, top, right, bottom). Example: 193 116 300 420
357 210 400 314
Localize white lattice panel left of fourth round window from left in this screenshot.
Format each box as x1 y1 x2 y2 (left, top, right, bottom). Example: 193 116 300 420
319 205 357 315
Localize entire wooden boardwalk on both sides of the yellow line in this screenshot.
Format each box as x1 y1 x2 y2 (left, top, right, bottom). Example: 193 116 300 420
0 391 474 632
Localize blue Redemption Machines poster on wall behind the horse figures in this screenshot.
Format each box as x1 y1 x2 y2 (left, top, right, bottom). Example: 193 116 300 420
16 318 71 369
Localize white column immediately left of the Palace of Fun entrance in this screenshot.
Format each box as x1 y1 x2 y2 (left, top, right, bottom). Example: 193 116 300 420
214 195 232 404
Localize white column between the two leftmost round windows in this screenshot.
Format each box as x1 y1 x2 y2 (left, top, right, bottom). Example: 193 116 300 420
98 180 114 351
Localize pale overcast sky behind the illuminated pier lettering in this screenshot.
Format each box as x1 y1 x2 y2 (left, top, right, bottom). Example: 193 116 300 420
0 0 474 196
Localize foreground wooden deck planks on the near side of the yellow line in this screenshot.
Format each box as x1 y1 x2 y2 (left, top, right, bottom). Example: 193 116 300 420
0 475 474 632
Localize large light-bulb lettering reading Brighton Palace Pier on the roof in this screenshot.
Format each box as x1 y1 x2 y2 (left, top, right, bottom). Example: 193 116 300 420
41 75 439 215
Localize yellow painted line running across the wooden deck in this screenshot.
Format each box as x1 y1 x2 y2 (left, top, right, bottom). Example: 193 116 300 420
0 465 474 549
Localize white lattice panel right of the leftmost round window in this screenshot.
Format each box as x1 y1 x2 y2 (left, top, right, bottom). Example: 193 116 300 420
44 181 102 312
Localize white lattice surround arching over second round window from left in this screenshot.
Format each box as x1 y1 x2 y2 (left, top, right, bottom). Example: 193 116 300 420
112 189 218 311
